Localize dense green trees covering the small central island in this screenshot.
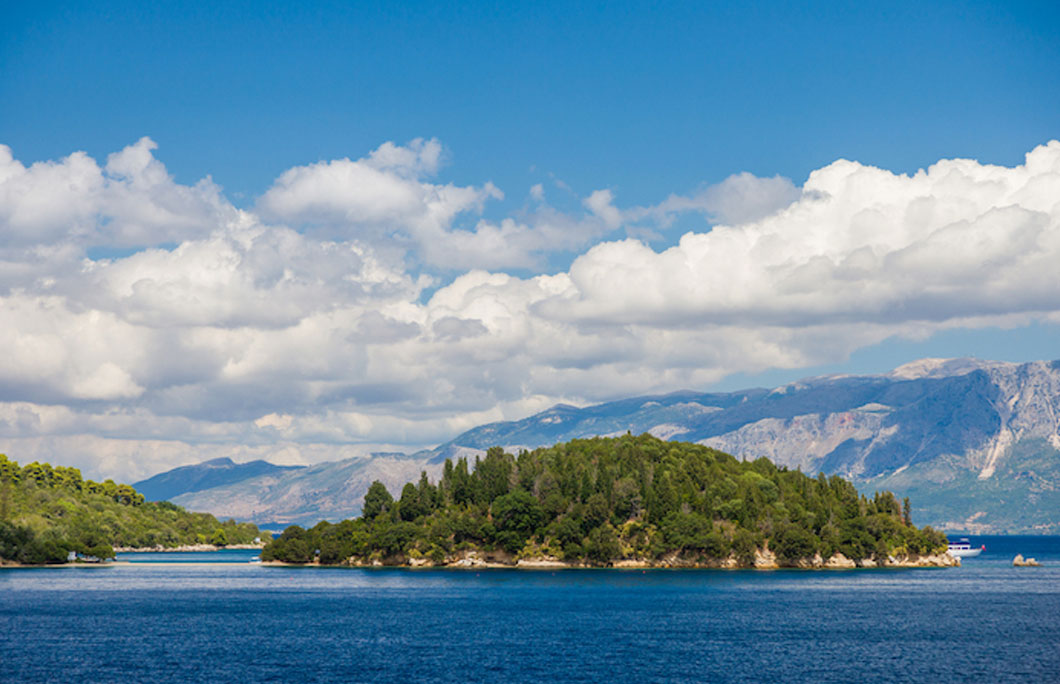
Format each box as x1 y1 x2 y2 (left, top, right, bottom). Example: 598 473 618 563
262 435 946 565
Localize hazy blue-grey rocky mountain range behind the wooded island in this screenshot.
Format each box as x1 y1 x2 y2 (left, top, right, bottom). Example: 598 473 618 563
137 358 1060 533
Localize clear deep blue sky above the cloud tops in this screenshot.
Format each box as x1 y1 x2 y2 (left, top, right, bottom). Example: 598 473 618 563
0 2 1060 204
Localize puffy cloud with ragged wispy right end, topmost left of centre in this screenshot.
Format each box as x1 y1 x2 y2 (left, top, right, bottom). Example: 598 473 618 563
258 139 623 270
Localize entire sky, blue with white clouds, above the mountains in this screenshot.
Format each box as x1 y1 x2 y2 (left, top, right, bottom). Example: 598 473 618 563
0 2 1060 480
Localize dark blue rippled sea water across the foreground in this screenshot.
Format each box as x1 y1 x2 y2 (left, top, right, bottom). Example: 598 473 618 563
0 537 1060 683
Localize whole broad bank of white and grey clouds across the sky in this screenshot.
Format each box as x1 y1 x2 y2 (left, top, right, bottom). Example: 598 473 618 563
0 138 1060 479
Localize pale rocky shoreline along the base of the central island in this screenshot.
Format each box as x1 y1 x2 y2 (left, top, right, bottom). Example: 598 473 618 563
262 548 960 569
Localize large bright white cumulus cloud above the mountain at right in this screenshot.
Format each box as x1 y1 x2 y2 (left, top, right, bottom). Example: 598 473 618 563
540 142 1060 327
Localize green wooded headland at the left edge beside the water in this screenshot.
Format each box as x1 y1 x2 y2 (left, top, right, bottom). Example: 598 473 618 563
0 454 258 563
